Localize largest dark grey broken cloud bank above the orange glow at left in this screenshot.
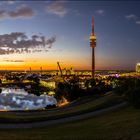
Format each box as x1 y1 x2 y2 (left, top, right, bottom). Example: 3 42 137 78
0 32 56 55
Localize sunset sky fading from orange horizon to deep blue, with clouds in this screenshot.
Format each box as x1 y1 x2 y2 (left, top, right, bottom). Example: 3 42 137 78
0 0 140 70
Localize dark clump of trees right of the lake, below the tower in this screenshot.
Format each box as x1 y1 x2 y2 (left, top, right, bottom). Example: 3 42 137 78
55 77 111 101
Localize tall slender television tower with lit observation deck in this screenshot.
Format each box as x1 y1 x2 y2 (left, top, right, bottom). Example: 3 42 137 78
89 17 96 78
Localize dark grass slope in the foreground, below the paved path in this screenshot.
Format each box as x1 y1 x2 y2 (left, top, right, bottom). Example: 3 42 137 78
0 106 140 140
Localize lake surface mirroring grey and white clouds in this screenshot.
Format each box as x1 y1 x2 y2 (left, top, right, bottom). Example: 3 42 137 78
0 88 57 111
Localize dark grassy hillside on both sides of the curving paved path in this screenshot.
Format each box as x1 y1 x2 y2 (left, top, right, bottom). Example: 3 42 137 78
0 95 140 140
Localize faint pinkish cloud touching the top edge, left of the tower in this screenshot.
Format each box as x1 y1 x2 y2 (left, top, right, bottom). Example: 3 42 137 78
46 0 68 17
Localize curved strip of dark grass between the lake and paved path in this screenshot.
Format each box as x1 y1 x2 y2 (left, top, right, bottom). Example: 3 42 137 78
0 94 122 123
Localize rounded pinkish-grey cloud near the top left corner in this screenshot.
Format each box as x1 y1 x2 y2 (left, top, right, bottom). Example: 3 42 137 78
8 5 34 18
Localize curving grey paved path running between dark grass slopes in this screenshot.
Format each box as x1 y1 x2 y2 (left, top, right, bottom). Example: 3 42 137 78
0 103 127 129
